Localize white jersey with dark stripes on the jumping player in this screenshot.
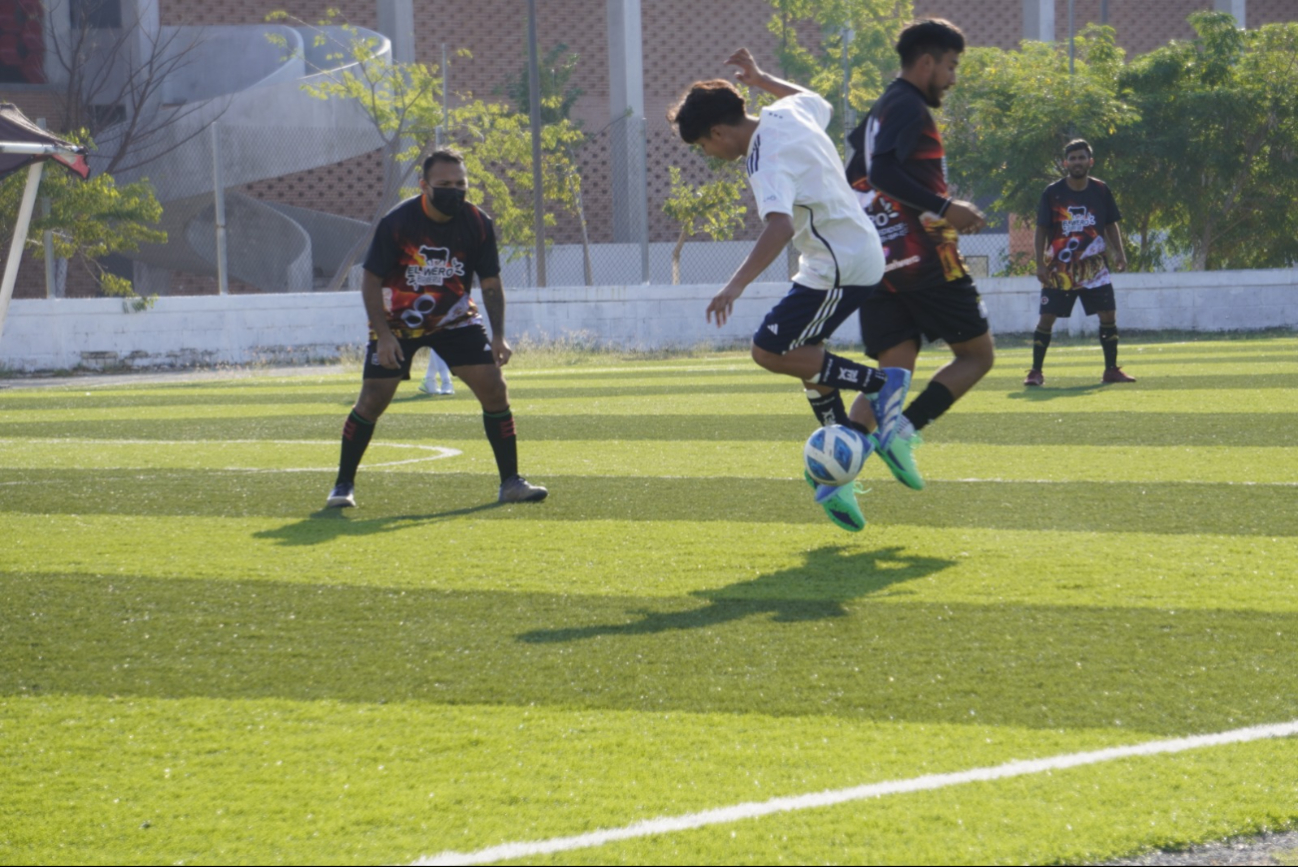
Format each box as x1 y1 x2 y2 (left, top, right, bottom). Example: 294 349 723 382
748 91 884 289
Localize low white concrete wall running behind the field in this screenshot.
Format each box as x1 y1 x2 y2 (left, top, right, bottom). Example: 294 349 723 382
0 270 1298 371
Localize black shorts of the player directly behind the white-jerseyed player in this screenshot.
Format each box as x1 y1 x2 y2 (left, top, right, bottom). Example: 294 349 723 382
861 279 992 358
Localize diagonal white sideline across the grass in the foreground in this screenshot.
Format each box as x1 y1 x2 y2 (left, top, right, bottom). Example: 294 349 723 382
413 720 1298 867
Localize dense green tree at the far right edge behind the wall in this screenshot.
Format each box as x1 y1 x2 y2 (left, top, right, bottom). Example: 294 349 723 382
1112 12 1298 270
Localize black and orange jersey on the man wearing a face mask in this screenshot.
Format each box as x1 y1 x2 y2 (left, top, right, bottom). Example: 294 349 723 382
365 196 500 339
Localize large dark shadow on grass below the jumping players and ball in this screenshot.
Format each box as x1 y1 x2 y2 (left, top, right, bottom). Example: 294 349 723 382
518 545 955 644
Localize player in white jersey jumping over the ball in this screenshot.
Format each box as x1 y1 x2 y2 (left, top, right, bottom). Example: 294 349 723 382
667 48 910 531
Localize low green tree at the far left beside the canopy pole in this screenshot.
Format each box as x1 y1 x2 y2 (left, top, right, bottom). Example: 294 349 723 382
0 142 166 296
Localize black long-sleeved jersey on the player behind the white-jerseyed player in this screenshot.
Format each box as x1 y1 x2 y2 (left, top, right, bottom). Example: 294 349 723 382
848 78 968 292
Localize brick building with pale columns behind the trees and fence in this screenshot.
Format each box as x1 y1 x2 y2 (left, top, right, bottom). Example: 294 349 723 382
0 0 1298 297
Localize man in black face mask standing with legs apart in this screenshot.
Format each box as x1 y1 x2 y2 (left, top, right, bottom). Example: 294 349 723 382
325 148 548 507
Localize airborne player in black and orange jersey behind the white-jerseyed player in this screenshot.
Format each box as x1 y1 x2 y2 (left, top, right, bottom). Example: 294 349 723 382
848 18 996 491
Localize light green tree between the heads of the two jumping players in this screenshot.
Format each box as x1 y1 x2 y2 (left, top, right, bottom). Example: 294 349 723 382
766 0 914 147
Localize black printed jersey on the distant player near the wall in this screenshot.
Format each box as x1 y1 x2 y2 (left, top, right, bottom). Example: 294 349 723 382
1037 178 1123 289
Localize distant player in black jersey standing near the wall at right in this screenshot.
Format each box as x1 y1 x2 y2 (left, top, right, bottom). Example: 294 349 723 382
1023 139 1136 385
